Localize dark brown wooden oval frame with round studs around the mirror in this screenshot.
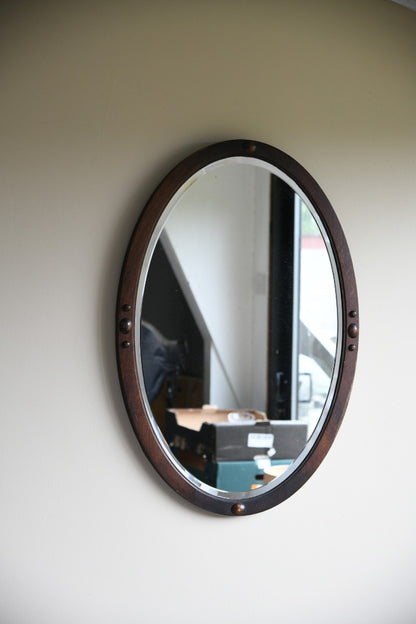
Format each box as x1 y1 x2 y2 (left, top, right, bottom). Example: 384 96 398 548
116 139 358 515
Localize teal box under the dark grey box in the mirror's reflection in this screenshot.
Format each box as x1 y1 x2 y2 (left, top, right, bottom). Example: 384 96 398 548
216 459 292 492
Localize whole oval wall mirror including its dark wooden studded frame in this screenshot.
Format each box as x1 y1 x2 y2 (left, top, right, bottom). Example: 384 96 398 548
117 140 358 515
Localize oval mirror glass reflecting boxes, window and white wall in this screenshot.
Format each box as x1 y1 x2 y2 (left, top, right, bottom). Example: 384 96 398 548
138 158 338 492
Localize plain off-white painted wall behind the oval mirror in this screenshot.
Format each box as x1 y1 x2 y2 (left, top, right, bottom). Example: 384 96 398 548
0 0 416 624
